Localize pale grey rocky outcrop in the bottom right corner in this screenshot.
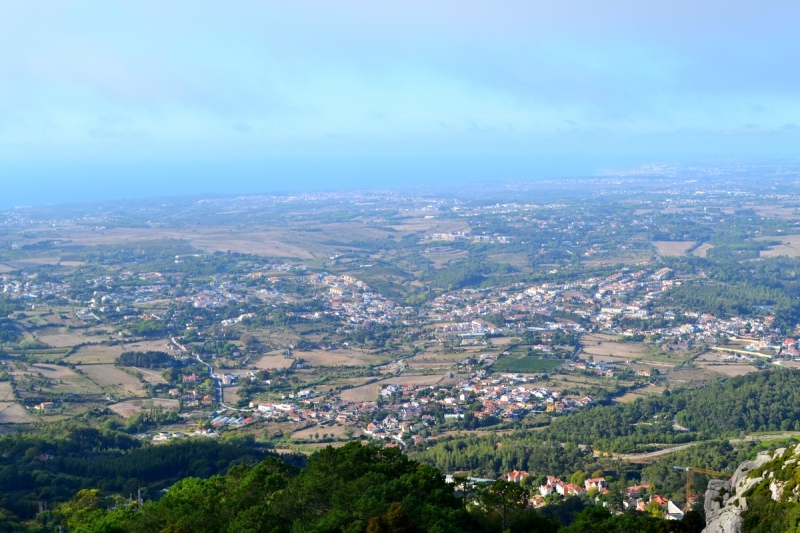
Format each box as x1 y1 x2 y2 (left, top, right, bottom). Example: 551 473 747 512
703 448 786 533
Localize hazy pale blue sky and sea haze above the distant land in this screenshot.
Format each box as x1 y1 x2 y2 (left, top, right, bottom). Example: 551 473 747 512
0 0 800 208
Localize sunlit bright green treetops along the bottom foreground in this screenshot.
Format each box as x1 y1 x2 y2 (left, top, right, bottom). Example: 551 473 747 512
34 443 702 533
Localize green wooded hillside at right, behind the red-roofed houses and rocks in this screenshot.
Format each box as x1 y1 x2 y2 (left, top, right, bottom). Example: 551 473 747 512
416 369 800 475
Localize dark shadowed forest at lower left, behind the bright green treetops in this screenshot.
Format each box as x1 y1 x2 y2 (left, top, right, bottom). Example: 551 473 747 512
0 422 303 518
